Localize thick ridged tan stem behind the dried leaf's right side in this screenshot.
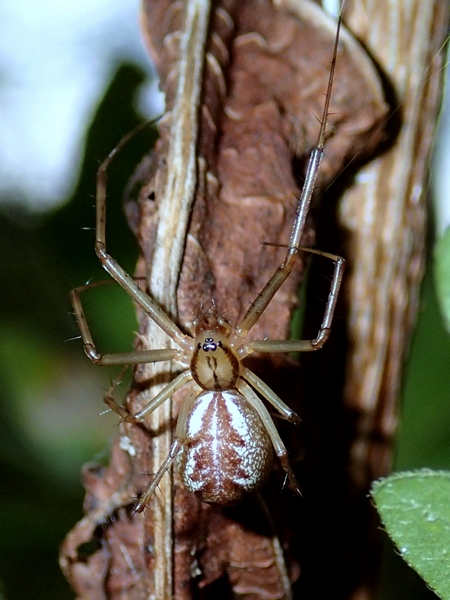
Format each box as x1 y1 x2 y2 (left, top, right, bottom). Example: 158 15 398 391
339 0 449 600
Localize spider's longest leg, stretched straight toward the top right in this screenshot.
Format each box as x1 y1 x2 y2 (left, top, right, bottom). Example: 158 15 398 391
236 17 341 339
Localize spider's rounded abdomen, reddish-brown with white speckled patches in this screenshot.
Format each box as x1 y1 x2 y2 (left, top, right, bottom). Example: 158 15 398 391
177 390 273 505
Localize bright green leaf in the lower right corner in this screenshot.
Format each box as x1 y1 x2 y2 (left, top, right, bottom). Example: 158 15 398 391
371 469 450 600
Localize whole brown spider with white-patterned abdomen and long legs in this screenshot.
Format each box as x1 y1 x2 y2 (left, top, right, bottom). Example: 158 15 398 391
71 21 345 512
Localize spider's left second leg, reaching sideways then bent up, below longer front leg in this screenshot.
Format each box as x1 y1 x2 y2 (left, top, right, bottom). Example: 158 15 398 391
70 284 181 365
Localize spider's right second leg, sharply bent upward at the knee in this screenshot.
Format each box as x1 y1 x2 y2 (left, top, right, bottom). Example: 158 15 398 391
239 248 345 358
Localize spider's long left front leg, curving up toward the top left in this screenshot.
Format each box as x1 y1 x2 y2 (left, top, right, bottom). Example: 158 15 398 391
95 132 192 350
